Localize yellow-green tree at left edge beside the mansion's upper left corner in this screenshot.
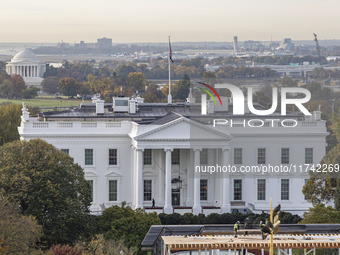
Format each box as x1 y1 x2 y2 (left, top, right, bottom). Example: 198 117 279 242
0 104 21 146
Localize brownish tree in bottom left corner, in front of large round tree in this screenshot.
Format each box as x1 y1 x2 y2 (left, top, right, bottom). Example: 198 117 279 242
0 196 42 254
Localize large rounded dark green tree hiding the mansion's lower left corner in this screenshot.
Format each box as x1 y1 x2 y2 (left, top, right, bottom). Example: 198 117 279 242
0 139 91 247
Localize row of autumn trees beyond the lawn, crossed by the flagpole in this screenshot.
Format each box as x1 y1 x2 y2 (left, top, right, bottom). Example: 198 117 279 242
42 72 190 102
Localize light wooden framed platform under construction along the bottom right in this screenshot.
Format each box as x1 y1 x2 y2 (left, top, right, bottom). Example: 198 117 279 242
162 234 340 255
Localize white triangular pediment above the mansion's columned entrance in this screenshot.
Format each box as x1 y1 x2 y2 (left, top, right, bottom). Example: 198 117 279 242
134 117 230 141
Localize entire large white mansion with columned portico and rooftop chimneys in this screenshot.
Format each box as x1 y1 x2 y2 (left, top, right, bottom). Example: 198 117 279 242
19 97 327 215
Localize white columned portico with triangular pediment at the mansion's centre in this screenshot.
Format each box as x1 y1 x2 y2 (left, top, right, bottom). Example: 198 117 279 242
133 118 230 214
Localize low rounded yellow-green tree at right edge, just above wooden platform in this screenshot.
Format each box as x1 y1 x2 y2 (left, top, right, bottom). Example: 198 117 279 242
300 204 340 224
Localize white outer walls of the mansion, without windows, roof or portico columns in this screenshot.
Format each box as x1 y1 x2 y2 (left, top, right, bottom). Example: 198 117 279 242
19 118 326 214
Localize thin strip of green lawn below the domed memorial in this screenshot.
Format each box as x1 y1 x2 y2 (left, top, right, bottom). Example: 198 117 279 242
0 97 91 108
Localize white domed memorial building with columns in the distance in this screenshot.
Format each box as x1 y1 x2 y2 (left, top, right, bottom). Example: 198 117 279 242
6 49 46 87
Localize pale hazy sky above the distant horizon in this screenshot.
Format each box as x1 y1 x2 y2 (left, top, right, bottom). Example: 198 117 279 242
0 0 340 43
